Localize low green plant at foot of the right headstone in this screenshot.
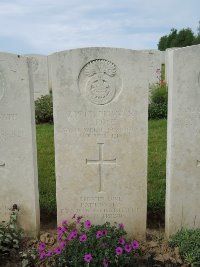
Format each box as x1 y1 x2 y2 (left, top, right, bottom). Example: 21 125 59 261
169 229 200 266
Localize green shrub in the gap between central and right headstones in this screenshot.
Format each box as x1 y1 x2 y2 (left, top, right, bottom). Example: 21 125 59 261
149 80 168 120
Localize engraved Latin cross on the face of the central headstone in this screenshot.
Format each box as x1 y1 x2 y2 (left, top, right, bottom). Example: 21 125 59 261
86 143 116 192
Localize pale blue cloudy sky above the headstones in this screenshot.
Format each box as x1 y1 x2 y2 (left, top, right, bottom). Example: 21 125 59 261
0 0 200 55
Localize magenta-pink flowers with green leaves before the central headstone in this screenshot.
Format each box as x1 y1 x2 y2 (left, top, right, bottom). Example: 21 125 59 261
38 215 139 267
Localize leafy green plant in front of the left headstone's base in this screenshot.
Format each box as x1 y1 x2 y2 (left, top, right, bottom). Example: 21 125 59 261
0 204 22 258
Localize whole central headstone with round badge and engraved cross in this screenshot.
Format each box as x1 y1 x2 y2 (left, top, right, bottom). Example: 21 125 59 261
51 48 149 238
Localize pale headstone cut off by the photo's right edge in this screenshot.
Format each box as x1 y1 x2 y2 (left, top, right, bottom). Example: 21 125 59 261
165 45 200 239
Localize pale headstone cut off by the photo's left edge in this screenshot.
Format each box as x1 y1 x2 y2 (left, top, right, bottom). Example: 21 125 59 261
0 53 39 236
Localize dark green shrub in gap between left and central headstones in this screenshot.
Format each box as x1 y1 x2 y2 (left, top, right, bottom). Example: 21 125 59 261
35 93 53 124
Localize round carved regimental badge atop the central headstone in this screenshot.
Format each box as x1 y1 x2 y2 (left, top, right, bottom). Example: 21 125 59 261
79 59 122 105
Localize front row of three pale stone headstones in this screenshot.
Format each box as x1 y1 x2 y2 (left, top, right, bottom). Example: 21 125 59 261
0 45 200 238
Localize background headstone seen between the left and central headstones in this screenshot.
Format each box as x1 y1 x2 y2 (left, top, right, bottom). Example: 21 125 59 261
26 54 50 100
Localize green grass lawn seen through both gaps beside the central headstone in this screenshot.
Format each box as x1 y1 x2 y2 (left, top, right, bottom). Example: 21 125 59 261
37 120 167 225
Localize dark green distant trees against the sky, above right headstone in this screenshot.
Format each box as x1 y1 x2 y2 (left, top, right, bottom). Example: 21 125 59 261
158 28 200 51
